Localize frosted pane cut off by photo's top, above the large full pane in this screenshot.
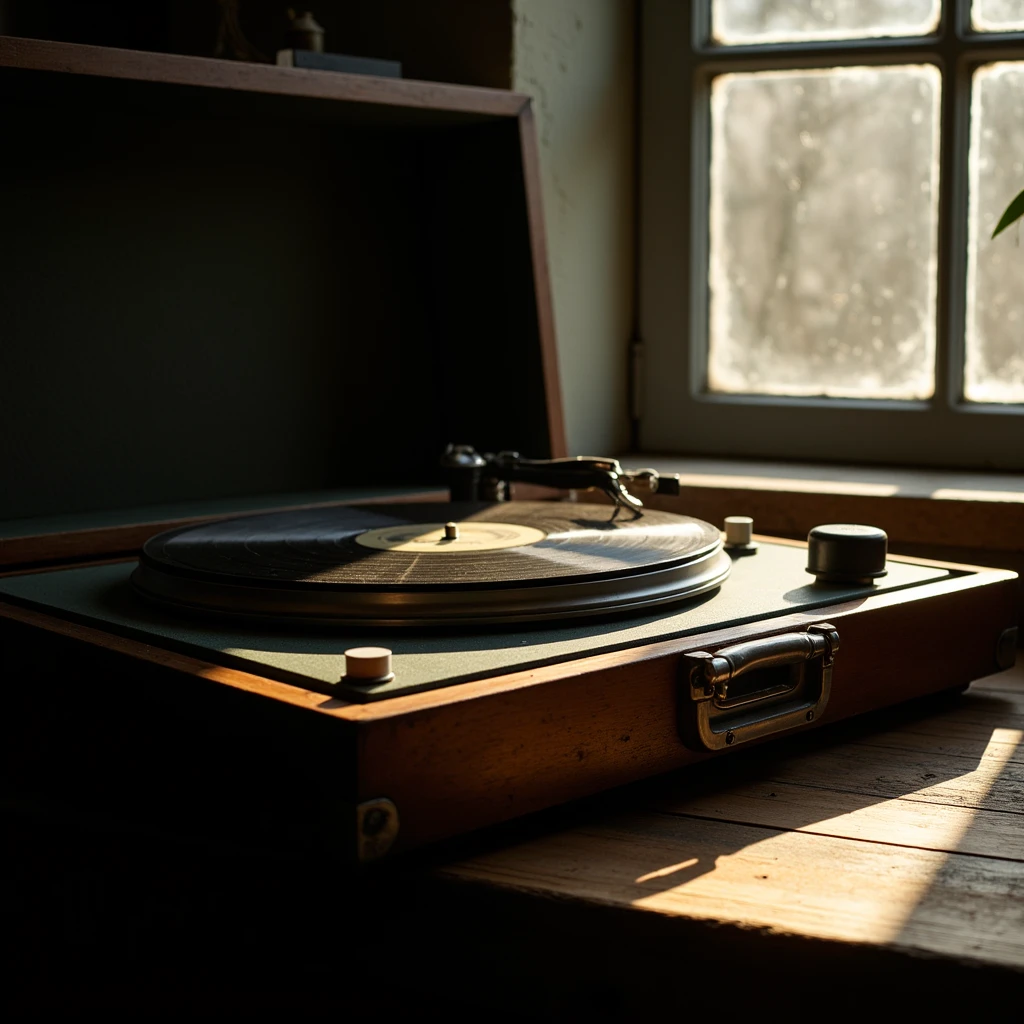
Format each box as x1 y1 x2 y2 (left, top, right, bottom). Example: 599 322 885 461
711 0 937 44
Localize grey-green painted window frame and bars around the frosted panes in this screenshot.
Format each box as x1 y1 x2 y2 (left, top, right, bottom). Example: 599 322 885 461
633 0 1024 470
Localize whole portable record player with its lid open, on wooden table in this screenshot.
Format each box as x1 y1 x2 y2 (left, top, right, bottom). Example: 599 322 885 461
0 40 1015 865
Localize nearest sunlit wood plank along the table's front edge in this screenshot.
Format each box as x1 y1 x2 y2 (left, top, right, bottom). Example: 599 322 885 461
441 812 1024 970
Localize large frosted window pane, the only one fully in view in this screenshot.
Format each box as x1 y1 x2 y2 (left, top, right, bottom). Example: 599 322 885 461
708 65 940 398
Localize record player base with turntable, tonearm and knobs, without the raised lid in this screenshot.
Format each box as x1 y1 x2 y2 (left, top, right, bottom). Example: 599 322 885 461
0 449 1016 860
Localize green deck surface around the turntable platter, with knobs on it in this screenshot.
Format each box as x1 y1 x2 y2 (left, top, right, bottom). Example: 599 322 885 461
0 544 950 700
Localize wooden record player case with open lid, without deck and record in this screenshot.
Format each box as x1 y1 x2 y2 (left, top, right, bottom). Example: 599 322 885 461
0 39 1015 864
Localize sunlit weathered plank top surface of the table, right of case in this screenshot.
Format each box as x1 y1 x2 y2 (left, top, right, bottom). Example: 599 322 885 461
440 669 1024 971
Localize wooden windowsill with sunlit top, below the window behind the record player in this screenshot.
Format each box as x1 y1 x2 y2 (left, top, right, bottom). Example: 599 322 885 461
621 455 1024 567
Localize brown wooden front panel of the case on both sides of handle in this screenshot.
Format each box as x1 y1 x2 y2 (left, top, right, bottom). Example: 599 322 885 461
358 573 1016 850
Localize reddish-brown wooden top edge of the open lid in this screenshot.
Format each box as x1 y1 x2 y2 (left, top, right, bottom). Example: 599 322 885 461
0 36 527 118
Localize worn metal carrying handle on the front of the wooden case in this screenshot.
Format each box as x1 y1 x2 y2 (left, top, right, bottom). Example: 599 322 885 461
679 623 839 751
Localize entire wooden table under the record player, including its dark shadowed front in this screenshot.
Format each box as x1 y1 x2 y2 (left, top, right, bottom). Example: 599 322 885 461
4 668 1024 1022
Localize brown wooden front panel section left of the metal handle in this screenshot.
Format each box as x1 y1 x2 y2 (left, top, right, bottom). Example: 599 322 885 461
358 654 701 849
